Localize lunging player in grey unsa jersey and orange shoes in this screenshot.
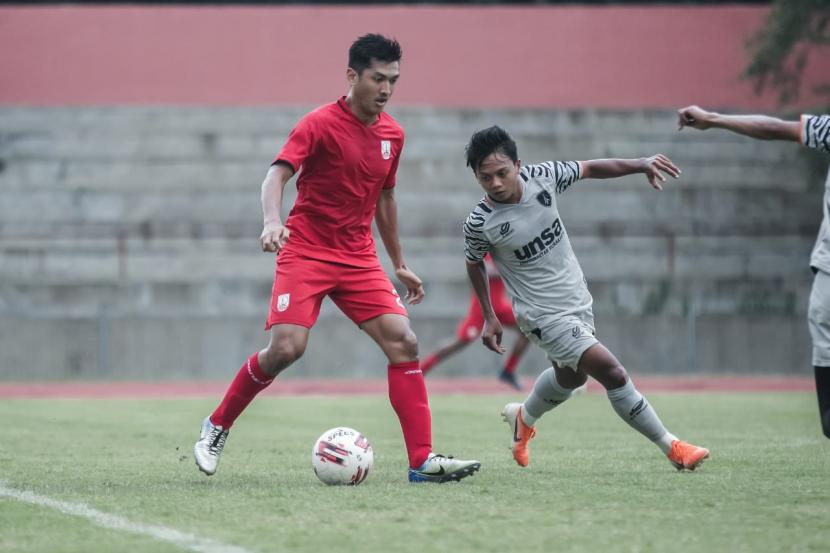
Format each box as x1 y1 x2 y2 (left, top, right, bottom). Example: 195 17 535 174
464 126 709 470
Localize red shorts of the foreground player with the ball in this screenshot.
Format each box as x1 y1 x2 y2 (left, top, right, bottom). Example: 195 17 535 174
265 253 408 330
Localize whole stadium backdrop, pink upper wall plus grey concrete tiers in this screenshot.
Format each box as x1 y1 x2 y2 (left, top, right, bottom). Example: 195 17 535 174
0 7 828 380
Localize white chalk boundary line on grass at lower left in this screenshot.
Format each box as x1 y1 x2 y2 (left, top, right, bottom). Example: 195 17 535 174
0 481 251 553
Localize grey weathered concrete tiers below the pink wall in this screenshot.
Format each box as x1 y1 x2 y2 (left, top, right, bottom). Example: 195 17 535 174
0 107 826 379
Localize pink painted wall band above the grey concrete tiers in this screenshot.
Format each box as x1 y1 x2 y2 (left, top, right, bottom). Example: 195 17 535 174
0 6 830 108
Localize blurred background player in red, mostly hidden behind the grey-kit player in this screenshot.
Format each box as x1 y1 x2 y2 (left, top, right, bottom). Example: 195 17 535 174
421 256 528 390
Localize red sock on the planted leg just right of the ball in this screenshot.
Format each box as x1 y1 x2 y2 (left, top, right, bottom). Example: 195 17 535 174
387 360 432 468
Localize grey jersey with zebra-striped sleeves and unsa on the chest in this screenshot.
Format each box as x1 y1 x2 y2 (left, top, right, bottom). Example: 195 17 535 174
464 161 593 326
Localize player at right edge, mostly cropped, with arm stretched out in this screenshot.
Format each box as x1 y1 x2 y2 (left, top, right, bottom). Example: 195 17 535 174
677 106 830 438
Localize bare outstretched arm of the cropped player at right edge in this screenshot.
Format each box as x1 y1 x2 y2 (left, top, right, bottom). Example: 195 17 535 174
677 106 801 142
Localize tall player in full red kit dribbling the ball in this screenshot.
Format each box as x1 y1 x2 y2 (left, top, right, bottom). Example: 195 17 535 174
194 34 480 482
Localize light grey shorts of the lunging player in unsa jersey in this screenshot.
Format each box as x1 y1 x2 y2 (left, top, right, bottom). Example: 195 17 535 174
516 311 599 370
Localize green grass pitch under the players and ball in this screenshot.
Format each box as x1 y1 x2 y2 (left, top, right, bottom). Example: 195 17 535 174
0 393 830 553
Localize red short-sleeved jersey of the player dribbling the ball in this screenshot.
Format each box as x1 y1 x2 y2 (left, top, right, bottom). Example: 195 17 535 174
274 97 404 267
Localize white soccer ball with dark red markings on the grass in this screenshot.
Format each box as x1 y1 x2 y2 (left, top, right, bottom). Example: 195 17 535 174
311 426 374 486
